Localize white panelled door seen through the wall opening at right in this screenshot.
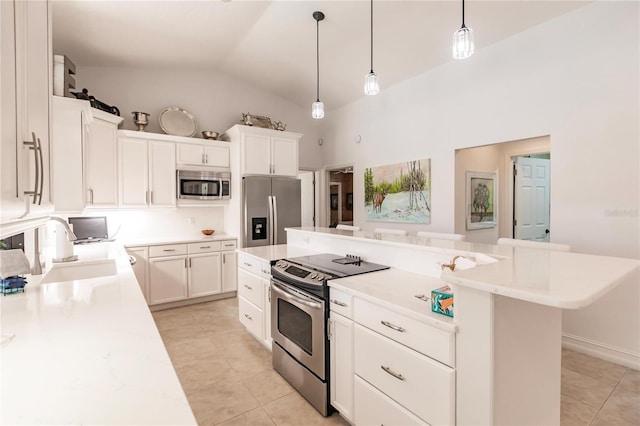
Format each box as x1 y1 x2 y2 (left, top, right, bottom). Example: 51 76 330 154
513 157 551 241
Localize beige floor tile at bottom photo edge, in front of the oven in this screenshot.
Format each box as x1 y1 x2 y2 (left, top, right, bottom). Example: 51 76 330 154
263 392 348 426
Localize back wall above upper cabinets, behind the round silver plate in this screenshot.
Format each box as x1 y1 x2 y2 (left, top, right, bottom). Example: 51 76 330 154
76 67 321 169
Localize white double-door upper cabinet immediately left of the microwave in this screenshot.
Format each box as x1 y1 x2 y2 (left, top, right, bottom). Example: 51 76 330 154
118 136 176 207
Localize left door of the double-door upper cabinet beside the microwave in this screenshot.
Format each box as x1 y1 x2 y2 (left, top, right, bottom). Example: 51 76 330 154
118 138 149 207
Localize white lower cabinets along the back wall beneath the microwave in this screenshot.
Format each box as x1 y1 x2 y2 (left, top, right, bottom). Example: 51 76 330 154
136 240 237 305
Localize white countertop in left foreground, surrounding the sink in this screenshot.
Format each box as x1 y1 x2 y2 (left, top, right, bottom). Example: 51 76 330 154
0 243 196 425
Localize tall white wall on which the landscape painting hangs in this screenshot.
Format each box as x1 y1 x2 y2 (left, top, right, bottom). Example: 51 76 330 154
320 2 640 366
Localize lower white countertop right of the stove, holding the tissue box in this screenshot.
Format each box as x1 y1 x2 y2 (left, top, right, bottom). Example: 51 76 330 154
329 268 456 332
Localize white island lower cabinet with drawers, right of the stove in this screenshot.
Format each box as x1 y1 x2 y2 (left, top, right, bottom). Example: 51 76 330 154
329 287 455 425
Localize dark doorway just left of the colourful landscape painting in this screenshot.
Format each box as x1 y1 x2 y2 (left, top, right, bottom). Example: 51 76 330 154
325 165 353 228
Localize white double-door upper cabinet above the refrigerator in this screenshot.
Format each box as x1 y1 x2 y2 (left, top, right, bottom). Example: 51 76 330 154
226 124 302 176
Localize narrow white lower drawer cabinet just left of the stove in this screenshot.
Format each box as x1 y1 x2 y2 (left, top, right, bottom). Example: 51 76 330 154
238 253 271 349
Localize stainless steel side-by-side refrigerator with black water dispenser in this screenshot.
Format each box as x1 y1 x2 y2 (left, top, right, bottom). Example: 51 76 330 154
242 176 302 247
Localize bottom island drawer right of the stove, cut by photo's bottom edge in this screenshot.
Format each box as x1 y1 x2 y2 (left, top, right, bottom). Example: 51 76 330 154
354 376 426 426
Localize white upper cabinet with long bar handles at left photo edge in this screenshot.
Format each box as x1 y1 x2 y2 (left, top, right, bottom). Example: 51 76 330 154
0 0 53 223
